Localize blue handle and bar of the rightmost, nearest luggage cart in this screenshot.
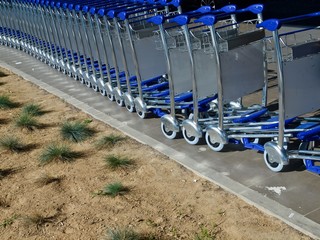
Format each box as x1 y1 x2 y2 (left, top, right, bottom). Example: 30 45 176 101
257 12 320 31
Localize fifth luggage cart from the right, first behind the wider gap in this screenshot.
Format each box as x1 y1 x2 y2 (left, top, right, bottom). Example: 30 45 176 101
114 1 181 115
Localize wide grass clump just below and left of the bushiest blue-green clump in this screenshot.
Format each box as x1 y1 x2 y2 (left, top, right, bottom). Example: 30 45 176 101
39 144 80 165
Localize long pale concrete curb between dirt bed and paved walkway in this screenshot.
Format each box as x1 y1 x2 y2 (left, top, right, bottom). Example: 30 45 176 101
0 60 320 239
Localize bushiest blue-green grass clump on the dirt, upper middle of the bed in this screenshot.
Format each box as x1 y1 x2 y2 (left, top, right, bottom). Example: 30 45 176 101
60 121 94 142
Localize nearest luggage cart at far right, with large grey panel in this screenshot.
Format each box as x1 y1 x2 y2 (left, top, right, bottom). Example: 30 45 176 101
257 12 320 174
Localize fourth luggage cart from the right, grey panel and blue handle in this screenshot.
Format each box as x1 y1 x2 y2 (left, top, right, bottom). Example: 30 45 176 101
148 6 236 139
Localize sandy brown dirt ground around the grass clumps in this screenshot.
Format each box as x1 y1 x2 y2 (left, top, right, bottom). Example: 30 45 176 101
0 66 309 240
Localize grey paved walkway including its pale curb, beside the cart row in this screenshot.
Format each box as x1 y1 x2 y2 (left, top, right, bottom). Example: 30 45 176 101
0 46 320 239
